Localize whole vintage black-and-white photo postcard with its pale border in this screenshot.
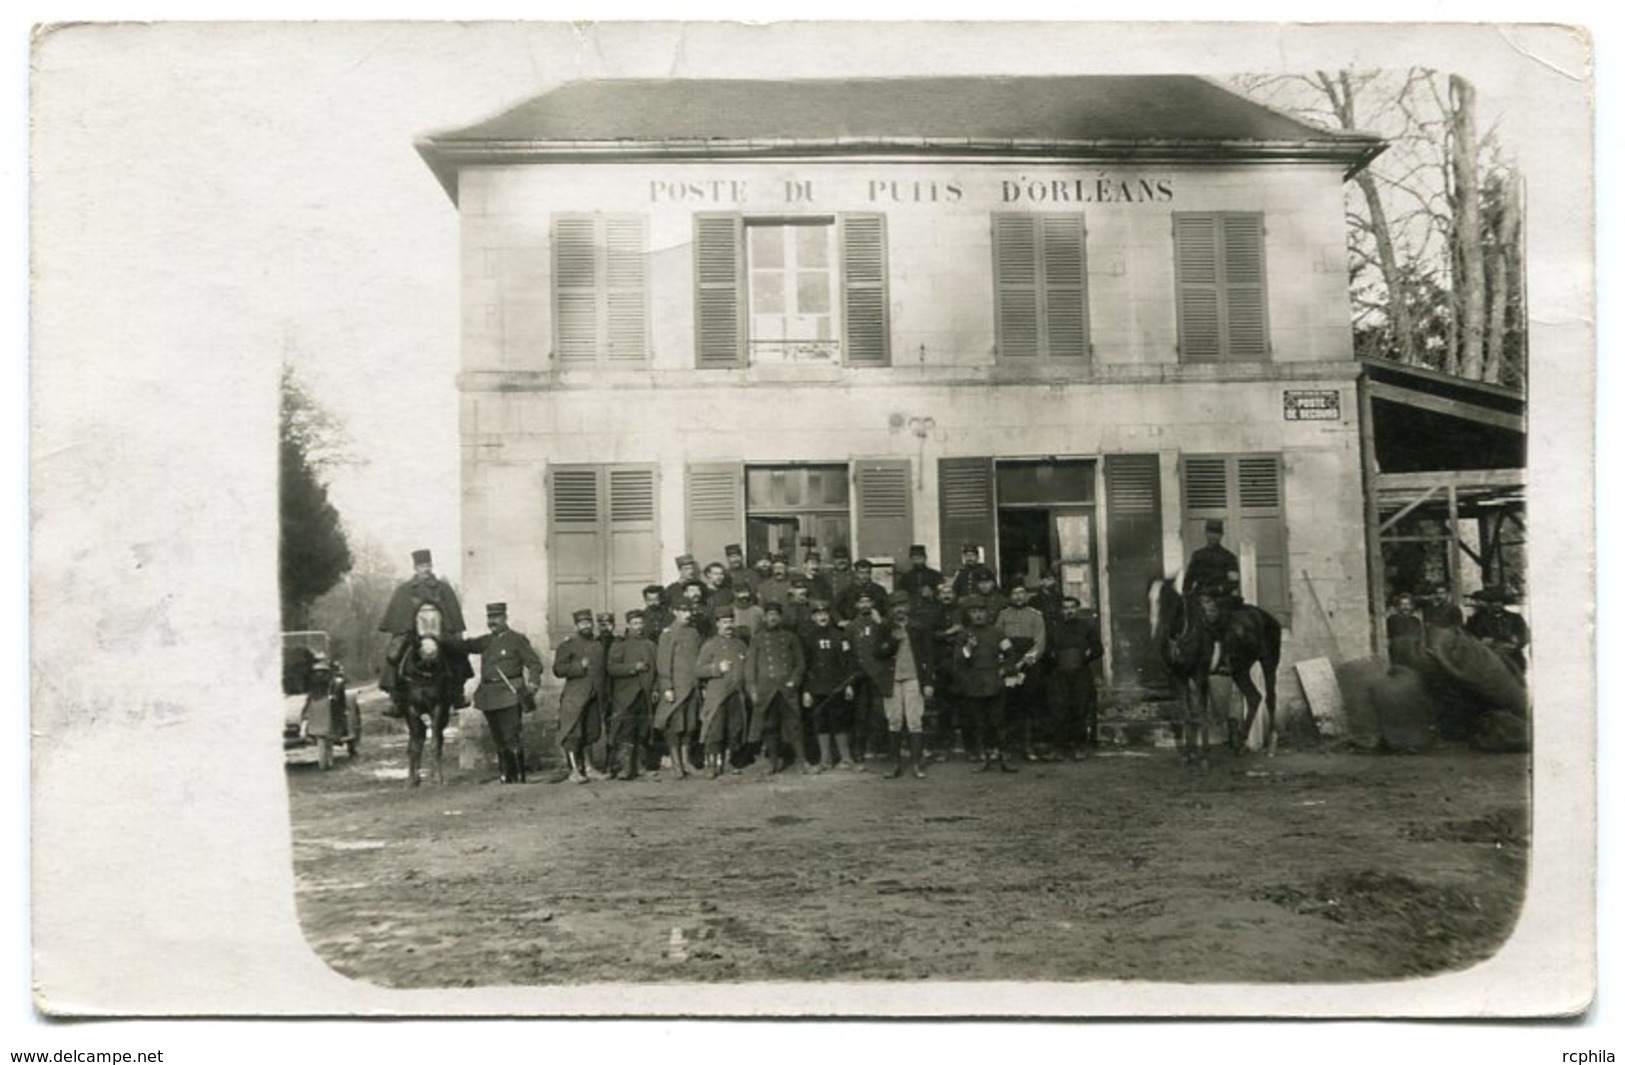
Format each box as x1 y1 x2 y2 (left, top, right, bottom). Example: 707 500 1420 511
29 21 1597 1019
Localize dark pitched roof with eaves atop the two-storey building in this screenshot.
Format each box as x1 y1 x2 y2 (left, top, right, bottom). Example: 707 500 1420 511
418 75 1385 198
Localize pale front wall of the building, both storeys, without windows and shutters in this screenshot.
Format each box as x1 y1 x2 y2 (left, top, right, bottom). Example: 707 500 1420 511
460 152 1370 715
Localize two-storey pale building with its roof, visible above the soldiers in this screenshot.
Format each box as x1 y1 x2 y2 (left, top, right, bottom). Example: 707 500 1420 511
419 76 1381 689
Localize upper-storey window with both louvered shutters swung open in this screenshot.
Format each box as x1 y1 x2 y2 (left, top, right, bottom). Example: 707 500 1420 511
694 213 891 369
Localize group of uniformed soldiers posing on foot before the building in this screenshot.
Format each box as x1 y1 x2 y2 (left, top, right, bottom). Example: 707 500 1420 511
372 545 1103 782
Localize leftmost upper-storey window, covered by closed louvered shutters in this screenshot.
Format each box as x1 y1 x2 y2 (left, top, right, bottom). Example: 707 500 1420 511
553 215 648 366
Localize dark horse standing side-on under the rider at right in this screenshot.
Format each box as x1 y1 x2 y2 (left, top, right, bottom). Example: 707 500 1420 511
1151 577 1281 761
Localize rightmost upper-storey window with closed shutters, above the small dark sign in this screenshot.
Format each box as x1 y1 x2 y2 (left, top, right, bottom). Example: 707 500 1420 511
1173 211 1269 363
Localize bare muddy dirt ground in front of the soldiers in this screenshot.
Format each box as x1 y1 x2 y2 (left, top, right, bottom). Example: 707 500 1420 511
288 699 1529 987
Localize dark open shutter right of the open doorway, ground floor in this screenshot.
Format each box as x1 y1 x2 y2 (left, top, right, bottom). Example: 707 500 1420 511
1105 455 1165 686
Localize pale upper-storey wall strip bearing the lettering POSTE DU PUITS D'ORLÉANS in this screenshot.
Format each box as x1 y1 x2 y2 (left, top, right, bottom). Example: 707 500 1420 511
458 161 1352 371
